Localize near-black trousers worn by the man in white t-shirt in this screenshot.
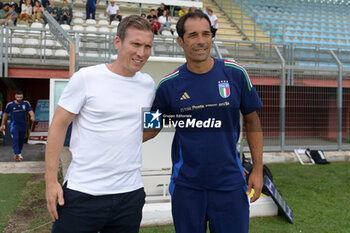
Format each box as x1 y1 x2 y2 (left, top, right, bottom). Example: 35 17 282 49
52 185 145 233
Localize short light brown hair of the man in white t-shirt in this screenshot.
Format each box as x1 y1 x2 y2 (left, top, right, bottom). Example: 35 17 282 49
117 15 153 41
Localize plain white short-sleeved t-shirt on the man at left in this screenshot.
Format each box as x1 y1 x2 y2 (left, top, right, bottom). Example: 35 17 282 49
58 64 155 195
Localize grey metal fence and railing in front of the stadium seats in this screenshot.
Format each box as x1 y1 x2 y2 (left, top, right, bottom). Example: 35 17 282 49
0 24 350 151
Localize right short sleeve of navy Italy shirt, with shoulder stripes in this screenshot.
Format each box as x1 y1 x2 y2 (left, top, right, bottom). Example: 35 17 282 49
240 70 262 115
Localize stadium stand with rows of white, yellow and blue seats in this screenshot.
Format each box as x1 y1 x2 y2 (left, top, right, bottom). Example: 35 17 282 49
3 0 350 67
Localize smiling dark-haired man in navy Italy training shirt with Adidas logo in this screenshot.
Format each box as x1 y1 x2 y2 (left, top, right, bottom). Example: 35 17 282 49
144 11 263 233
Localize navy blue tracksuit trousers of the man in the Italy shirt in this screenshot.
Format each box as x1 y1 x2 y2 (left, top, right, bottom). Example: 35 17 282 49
171 185 249 233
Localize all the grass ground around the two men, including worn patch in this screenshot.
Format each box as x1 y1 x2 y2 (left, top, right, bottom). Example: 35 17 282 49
0 163 350 233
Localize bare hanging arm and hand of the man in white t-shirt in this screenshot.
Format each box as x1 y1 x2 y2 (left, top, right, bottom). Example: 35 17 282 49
45 106 75 221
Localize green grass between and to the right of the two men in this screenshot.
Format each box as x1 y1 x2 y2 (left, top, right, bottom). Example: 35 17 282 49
140 163 350 233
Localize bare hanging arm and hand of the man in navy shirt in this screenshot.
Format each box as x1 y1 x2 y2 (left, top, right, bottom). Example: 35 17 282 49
243 111 263 202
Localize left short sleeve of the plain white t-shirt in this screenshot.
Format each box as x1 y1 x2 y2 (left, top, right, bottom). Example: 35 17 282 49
58 71 86 114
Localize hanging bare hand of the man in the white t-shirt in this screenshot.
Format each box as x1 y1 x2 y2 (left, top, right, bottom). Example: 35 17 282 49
46 181 64 221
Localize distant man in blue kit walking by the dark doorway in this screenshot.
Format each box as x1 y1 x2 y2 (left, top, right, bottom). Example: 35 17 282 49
0 91 35 162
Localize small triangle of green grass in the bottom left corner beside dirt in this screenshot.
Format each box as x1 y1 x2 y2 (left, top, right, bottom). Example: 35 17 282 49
0 174 30 232
